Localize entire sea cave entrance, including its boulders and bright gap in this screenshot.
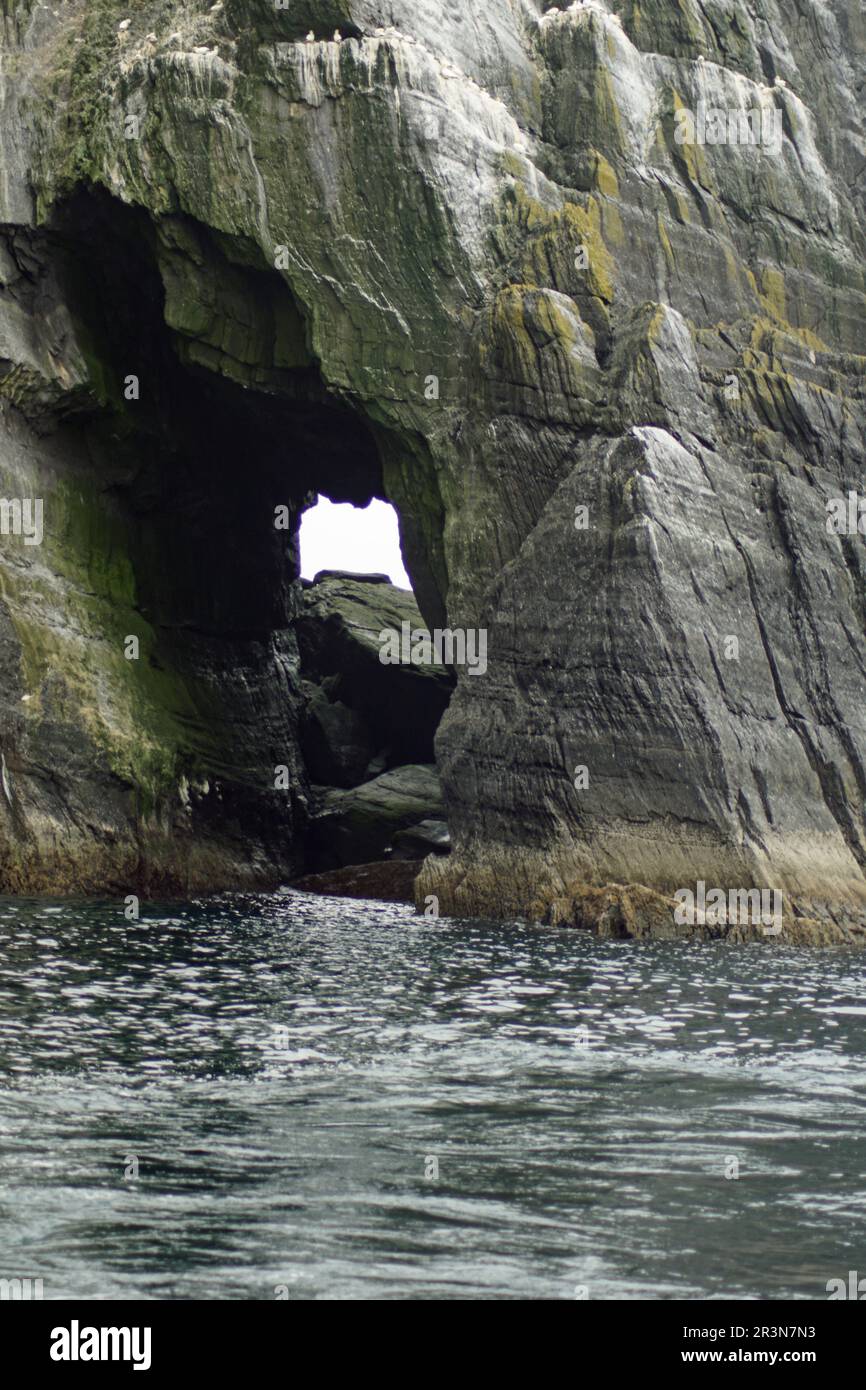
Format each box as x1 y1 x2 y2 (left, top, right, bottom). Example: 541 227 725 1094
33 189 455 888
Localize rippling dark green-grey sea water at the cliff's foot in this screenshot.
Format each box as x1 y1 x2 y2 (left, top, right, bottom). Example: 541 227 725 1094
0 892 866 1298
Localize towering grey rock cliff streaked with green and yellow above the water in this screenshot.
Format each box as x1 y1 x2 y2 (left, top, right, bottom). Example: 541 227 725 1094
0 0 866 937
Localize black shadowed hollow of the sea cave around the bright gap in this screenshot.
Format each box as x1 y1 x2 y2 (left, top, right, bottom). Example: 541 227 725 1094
33 189 453 872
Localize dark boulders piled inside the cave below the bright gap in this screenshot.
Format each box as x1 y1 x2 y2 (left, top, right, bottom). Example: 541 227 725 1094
296 570 453 891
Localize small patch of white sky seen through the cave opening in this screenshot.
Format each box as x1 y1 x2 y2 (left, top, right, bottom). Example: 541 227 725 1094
300 496 411 589
